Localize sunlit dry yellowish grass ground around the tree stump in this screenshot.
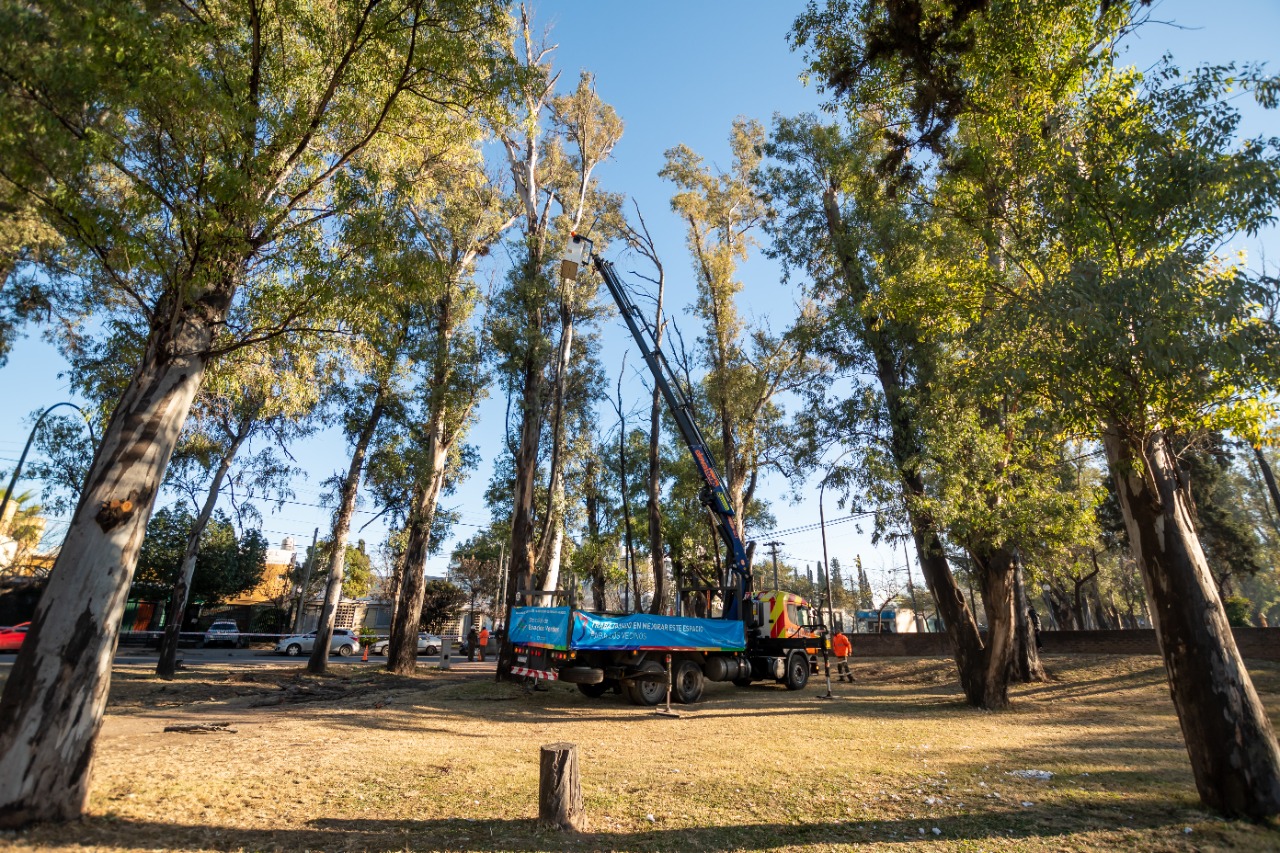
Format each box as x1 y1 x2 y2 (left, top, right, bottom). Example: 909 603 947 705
0 657 1280 850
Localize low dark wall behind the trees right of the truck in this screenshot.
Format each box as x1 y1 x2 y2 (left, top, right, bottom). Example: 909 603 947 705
850 628 1280 661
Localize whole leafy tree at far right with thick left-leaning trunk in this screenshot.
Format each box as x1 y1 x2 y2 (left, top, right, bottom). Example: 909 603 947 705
1009 59 1280 817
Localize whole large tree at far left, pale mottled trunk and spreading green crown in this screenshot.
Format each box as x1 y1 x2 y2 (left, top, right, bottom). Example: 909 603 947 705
0 0 507 826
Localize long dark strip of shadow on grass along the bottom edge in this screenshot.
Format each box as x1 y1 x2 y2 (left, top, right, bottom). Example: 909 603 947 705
15 809 1203 852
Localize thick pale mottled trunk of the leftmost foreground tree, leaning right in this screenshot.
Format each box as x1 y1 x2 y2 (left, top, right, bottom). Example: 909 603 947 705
0 300 217 827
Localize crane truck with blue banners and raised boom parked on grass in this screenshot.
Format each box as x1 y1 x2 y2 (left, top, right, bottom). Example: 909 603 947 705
508 234 829 706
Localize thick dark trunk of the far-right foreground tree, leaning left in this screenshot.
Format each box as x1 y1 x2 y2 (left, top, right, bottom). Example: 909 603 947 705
1103 427 1280 818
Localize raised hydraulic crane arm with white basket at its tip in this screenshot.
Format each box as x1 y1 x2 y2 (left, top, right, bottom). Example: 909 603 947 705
561 234 754 622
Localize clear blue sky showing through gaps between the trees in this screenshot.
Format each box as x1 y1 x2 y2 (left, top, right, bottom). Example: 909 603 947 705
0 0 1280 596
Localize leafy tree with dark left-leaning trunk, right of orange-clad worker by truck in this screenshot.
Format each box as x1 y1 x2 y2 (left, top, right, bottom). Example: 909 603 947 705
763 114 987 704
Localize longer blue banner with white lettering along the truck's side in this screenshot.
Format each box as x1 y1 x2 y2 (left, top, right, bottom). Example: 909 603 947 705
570 611 746 652
